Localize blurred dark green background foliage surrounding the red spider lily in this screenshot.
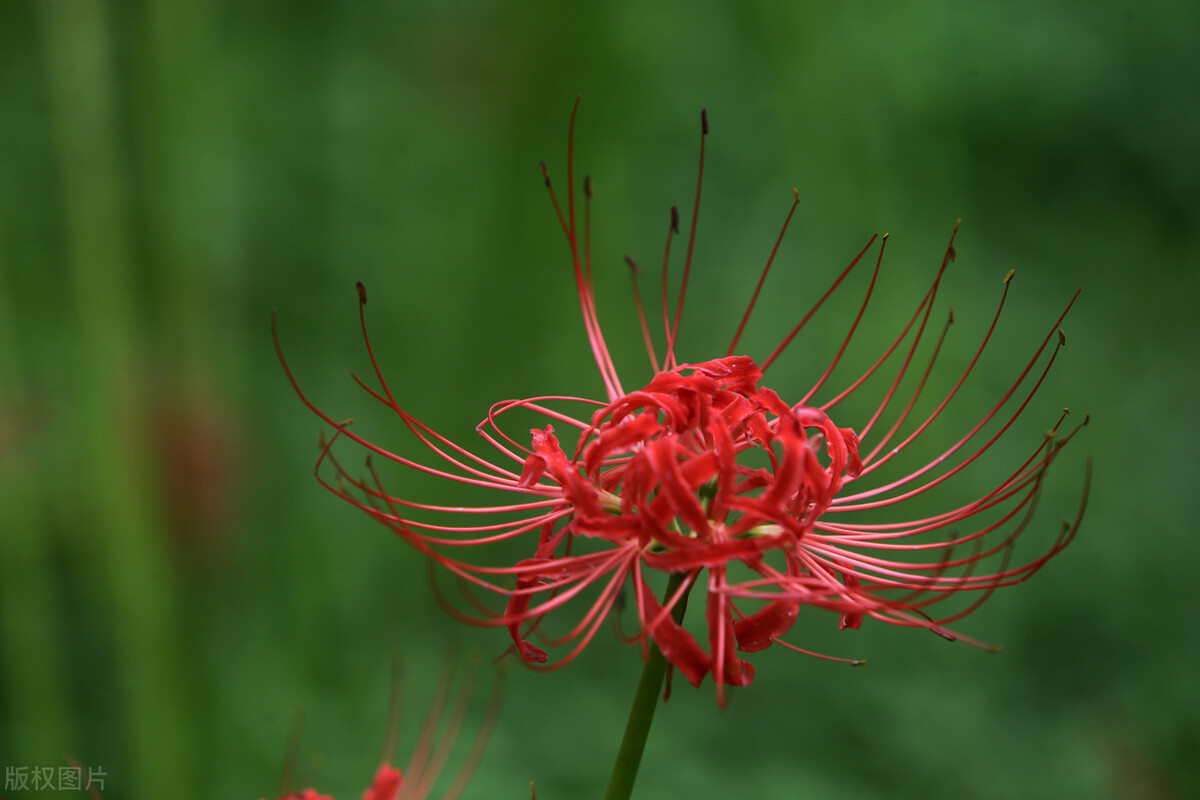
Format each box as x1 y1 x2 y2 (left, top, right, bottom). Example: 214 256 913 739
0 0 1200 798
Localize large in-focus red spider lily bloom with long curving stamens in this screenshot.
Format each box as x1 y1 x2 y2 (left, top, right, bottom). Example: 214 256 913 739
276 98 1087 702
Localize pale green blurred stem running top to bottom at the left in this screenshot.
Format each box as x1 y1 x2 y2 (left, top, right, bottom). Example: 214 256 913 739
37 2 194 798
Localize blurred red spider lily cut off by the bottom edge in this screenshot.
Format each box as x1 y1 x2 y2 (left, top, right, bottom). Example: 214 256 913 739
266 658 502 800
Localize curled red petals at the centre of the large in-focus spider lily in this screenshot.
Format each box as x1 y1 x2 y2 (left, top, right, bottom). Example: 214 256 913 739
506 356 863 685
